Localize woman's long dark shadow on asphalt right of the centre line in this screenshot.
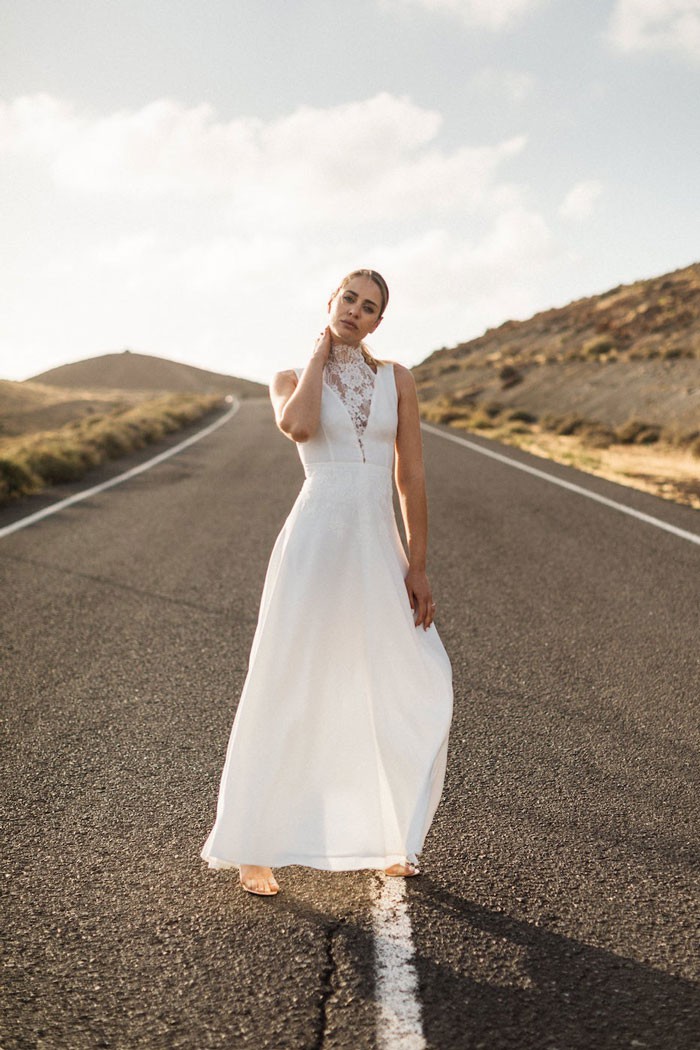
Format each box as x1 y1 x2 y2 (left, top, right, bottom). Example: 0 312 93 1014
411 878 700 1050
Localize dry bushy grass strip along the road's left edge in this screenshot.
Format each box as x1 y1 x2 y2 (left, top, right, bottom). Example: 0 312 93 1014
0 394 221 504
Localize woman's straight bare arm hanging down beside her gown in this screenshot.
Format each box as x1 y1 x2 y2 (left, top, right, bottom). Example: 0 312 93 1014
391 364 434 630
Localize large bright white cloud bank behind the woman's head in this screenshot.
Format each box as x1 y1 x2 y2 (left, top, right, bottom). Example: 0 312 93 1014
0 93 563 379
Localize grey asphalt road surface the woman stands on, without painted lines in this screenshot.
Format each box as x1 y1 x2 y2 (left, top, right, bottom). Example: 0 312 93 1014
0 402 700 1050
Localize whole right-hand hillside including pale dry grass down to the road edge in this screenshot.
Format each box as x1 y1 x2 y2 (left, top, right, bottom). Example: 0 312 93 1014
412 263 700 507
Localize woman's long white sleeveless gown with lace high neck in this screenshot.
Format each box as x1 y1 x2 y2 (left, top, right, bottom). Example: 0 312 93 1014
201 347 452 870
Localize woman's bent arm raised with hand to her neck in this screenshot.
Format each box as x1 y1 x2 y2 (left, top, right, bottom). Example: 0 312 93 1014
270 329 331 441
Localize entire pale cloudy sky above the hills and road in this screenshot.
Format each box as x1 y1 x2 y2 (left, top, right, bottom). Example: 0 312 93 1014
0 0 700 383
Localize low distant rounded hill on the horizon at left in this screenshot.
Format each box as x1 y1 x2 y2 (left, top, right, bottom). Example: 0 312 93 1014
27 350 268 398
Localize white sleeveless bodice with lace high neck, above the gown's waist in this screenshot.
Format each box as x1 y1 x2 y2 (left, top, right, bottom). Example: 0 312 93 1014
294 347 398 475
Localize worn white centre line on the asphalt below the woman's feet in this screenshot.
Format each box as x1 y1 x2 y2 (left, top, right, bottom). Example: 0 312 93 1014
372 874 427 1050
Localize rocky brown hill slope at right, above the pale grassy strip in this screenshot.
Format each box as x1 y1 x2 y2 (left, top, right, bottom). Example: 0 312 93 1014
413 264 700 428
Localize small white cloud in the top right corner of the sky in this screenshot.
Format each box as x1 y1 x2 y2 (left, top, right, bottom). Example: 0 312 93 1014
608 0 700 59
